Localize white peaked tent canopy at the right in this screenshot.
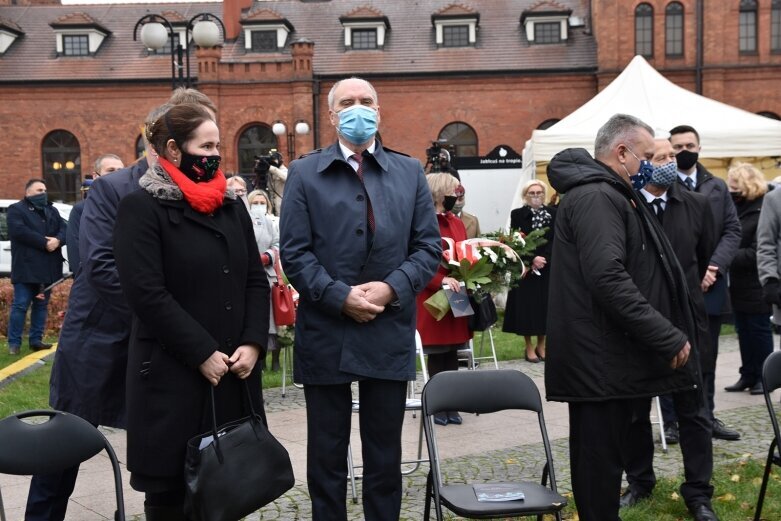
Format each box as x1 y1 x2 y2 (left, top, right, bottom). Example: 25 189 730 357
523 56 781 177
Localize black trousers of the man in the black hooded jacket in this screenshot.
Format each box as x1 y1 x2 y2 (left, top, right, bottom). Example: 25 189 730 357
569 398 648 521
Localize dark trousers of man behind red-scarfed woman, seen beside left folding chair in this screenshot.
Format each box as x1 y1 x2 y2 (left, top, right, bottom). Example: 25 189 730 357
24 465 79 521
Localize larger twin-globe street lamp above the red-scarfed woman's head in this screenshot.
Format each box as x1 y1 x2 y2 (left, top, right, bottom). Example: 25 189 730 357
133 13 225 89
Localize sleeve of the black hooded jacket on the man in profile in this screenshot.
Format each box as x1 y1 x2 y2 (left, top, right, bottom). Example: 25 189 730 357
559 191 686 360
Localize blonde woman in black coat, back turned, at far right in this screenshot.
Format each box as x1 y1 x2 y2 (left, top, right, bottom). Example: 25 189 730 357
725 163 773 394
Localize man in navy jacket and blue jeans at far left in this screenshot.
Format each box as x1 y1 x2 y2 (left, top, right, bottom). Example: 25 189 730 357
8 179 65 355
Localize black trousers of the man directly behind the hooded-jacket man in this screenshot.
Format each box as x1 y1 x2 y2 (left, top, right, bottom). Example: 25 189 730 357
624 390 713 508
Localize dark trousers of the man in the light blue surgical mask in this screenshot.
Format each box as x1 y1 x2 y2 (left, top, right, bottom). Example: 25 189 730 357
304 379 407 521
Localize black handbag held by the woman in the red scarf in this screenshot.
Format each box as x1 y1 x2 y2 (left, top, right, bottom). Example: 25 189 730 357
184 380 295 521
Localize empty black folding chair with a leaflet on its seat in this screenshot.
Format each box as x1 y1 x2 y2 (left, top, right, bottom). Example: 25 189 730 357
423 370 567 521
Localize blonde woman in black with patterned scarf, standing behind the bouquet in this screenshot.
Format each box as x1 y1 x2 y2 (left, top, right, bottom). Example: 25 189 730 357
502 179 556 364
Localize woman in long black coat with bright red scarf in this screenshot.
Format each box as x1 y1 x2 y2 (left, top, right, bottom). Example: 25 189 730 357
114 104 269 521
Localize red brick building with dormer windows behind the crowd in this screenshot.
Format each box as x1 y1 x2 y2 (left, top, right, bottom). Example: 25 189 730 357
0 0 781 201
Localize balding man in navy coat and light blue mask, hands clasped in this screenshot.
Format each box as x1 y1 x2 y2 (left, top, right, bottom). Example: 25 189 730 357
280 78 441 521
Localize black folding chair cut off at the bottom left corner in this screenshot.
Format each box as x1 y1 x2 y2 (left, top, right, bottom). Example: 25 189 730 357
0 411 125 521
